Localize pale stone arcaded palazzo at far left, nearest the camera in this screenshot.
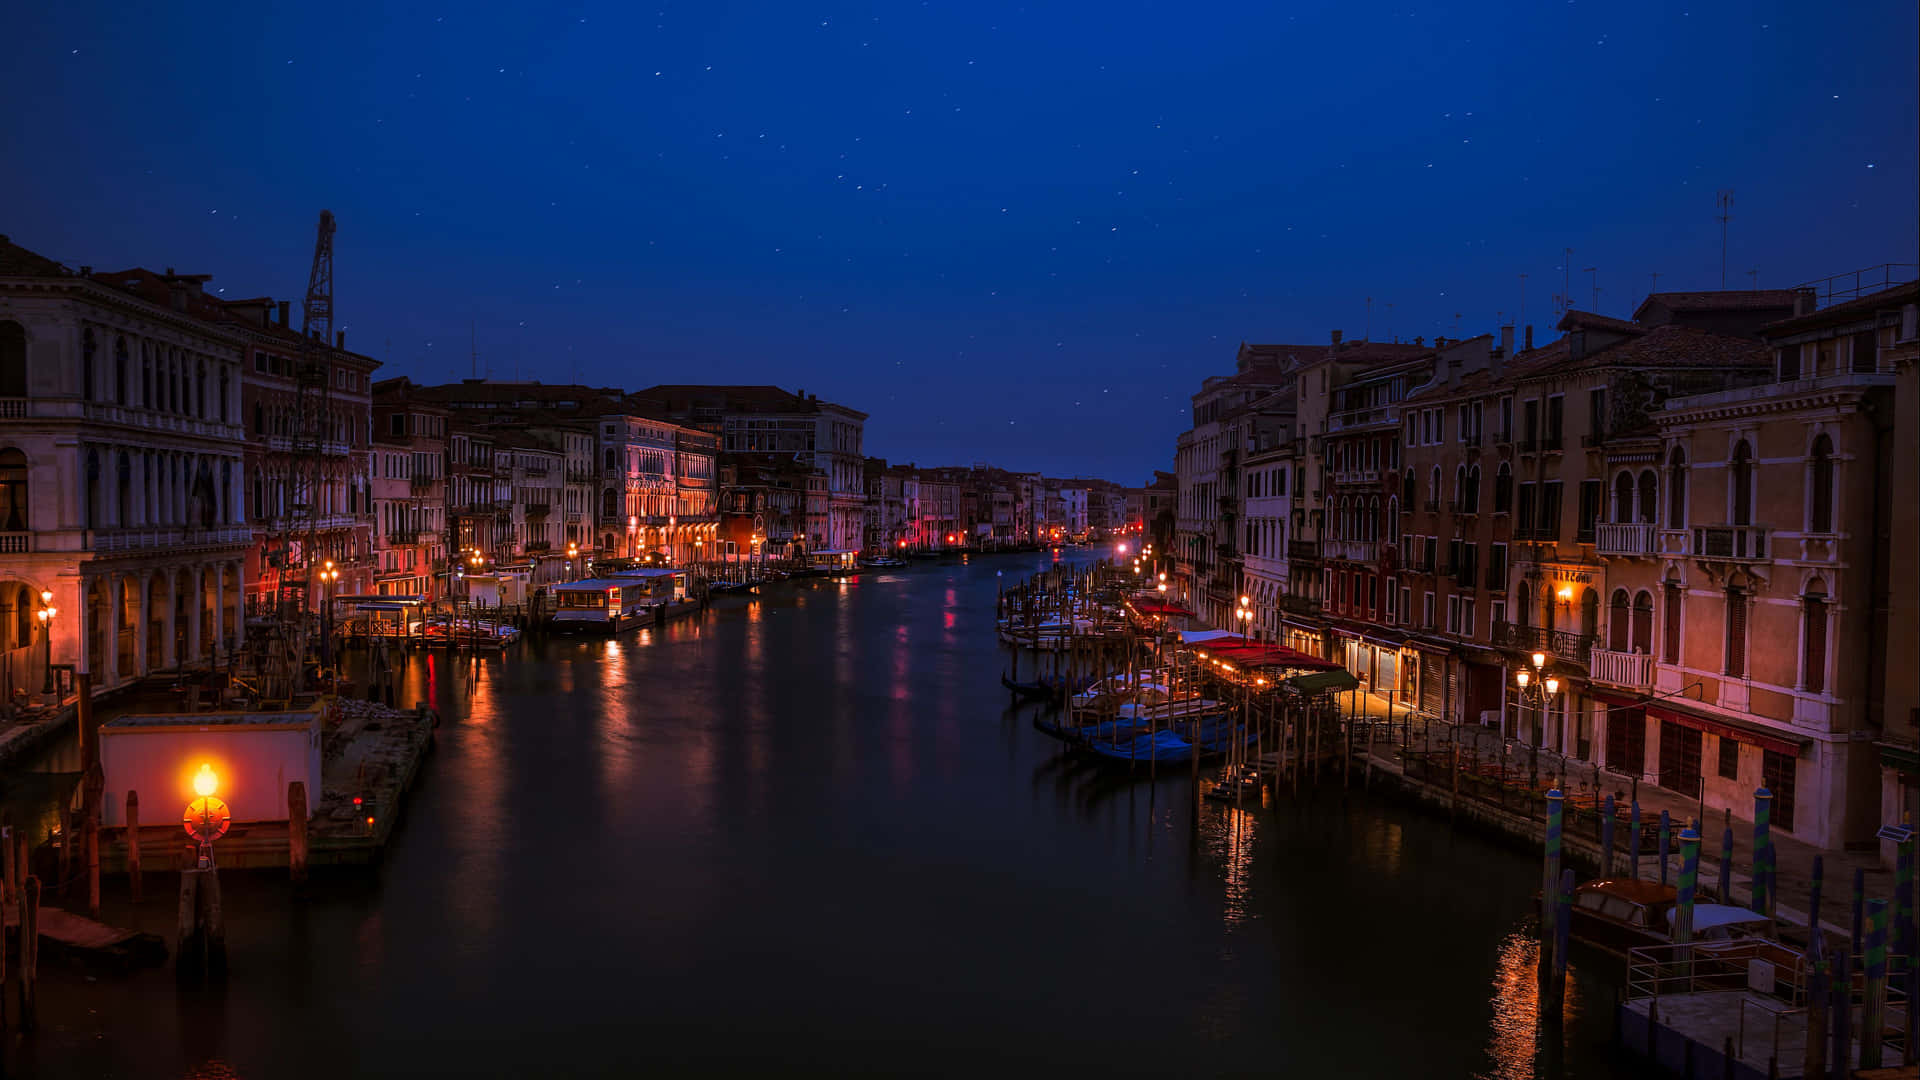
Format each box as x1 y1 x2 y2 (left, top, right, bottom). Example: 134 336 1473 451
0 236 252 701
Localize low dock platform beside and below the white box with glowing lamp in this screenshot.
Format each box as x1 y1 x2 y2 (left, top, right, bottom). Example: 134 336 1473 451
100 700 436 874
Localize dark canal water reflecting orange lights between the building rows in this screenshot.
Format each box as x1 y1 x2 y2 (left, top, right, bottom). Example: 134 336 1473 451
22 555 1630 1080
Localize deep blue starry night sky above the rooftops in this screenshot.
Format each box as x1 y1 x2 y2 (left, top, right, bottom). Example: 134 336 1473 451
0 0 1920 482
